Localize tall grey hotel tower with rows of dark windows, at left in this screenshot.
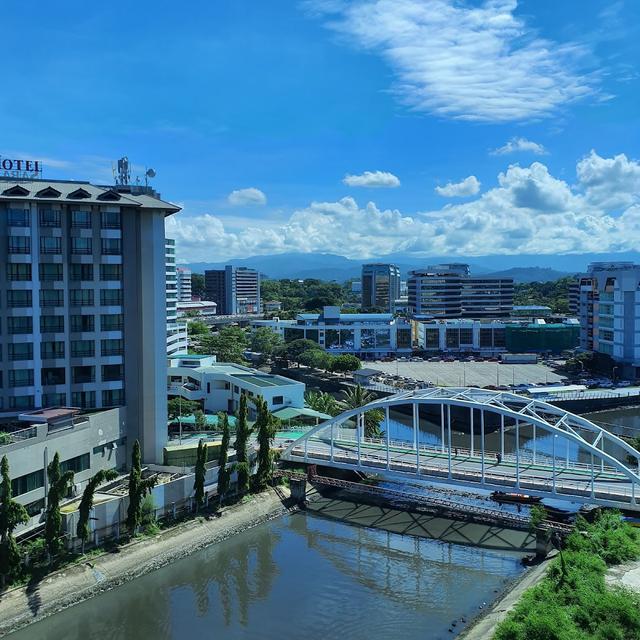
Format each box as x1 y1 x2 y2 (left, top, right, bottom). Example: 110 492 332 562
0 178 180 462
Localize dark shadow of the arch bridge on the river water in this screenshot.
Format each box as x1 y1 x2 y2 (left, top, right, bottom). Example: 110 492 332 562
307 497 536 553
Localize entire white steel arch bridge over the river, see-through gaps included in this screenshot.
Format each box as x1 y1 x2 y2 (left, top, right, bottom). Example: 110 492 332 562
281 387 640 511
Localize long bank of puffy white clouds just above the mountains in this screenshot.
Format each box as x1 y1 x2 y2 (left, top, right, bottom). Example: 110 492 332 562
167 152 640 262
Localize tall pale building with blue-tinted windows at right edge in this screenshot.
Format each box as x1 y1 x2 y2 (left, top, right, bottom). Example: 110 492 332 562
579 262 640 378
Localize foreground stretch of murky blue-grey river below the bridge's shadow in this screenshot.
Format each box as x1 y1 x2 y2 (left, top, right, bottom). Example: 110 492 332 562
10 513 522 640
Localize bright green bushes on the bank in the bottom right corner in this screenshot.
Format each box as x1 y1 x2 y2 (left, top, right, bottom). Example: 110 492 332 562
494 512 640 640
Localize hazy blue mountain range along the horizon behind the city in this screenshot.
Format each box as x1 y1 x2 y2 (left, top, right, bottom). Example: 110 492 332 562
178 251 640 282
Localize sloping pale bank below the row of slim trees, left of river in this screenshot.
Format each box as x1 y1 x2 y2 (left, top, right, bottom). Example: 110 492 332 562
0 487 289 637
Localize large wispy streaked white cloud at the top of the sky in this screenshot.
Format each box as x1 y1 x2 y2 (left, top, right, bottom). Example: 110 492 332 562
305 0 595 122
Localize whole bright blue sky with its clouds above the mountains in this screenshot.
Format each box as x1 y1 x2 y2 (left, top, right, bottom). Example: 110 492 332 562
0 0 640 261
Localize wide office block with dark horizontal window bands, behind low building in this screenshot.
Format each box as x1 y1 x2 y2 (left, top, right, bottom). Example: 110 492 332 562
407 263 513 319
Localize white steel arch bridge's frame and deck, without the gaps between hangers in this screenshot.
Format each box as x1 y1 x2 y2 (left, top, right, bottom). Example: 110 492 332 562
282 387 640 508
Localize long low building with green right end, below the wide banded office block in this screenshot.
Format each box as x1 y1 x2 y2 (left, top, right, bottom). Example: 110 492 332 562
415 319 580 356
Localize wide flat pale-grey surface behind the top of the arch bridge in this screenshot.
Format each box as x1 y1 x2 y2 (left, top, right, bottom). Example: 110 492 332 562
365 361 565 387
